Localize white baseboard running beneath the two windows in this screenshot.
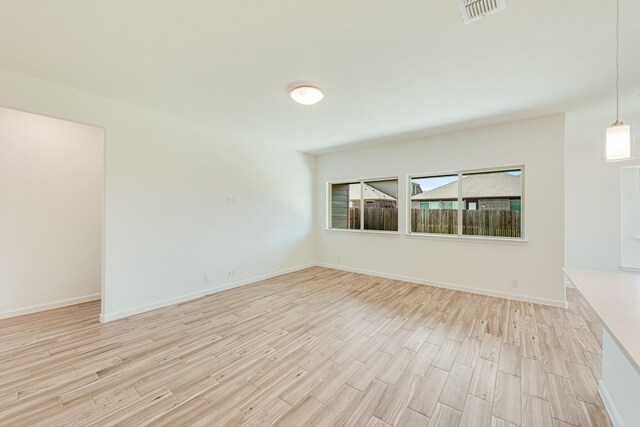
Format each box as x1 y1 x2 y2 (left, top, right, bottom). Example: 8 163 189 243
316 263 567 308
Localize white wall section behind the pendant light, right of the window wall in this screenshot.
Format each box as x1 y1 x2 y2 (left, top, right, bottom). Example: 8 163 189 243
565 96 640 271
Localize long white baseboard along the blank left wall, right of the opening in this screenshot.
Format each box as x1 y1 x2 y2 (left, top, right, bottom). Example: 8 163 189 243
100 263 315 323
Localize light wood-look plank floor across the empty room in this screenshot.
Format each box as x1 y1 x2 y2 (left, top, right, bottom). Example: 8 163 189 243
0 267 610 427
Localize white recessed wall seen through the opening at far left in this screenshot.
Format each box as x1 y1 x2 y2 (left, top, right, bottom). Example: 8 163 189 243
0 108 103 318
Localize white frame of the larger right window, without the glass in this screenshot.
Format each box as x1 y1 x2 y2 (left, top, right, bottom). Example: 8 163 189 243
405 164 527 242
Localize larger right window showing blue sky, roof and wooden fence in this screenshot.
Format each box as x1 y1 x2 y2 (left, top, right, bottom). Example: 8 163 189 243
410 168 523 238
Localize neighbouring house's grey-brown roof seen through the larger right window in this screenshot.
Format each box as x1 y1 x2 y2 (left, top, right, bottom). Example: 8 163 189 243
411 173 522 200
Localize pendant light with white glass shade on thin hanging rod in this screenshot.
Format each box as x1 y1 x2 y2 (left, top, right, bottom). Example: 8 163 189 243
604 0 635 162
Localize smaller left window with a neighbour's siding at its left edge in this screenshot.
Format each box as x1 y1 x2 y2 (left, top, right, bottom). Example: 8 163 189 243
329 179 400 231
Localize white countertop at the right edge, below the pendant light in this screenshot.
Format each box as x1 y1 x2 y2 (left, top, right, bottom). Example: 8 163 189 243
564 268 640 373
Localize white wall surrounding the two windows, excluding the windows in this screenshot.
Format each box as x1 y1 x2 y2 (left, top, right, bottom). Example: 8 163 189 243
316 115 565 305
